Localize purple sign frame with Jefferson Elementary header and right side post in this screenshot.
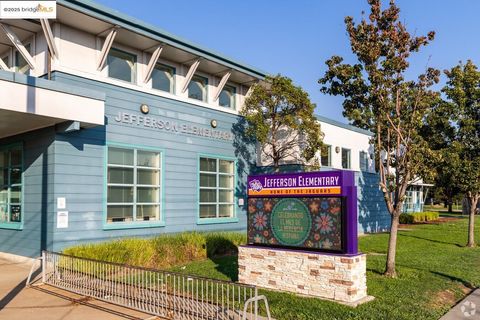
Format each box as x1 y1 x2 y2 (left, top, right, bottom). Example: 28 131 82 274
247 170 358 255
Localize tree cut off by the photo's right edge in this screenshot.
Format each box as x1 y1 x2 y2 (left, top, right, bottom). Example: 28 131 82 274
442 60 480 247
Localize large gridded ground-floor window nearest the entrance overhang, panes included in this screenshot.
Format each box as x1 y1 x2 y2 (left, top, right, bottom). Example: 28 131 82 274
107 147 161 223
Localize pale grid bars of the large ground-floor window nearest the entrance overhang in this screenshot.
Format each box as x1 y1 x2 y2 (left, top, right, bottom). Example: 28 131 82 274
107 147 162 223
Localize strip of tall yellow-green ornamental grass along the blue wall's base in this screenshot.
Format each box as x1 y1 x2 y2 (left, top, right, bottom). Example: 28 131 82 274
63 232 246 268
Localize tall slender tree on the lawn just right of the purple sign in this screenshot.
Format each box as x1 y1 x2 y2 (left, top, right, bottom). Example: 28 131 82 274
319 0 440 277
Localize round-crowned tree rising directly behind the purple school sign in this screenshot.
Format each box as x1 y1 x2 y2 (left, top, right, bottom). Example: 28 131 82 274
241 75 323 170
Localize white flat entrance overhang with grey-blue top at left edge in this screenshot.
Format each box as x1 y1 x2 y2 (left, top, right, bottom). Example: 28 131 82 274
0 72 105 138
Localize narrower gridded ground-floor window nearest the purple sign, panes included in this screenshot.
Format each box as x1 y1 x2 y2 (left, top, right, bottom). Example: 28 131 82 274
199 157 235 219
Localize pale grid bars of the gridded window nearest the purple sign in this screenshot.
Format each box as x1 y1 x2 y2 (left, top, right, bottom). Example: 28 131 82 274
199 157 235 219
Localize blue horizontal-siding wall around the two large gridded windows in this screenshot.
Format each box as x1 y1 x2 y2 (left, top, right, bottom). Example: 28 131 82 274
48 73 255 250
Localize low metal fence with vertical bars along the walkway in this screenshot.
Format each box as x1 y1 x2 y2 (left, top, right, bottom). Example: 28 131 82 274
35 251 270 320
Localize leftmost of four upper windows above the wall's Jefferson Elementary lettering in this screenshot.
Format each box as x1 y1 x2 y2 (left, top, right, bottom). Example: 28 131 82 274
107 48 137 83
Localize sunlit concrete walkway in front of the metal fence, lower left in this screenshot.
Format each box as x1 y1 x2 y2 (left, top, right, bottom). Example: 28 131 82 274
0 259 155 320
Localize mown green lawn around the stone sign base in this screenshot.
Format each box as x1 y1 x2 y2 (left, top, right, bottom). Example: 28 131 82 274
172 217 480 320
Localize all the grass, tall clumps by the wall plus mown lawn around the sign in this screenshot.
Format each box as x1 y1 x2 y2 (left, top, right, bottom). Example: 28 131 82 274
65 214 480 320
